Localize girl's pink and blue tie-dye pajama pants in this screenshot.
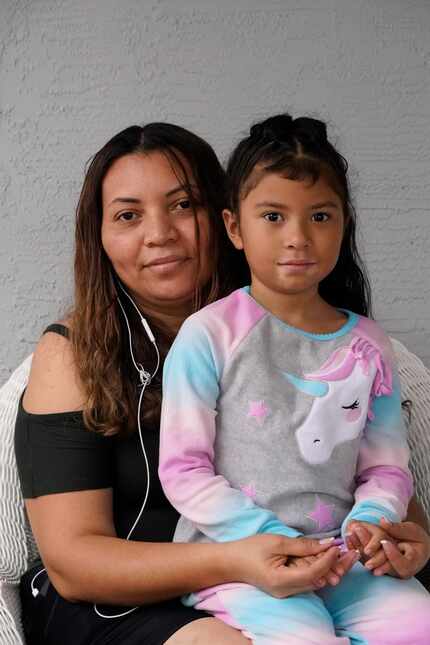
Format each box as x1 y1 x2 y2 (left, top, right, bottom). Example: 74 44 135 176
184 563 430 645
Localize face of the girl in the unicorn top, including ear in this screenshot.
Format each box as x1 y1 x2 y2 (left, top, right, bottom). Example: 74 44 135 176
224 173 344 306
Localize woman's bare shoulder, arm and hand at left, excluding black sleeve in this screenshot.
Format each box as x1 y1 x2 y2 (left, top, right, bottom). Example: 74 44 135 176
24 334 337 605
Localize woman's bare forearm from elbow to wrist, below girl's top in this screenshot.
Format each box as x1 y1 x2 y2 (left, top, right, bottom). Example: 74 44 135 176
51 536 240 605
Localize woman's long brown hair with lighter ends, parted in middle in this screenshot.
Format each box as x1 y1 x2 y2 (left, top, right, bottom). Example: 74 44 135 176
71 123 248 435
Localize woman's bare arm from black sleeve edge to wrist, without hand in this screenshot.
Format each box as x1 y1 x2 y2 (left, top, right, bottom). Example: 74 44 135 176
26 489 242 605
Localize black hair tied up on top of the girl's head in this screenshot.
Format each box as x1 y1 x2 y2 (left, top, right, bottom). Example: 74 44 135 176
250 113 327 144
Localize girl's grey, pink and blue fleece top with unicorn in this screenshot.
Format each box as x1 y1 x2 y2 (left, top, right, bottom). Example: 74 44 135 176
159 288 412 542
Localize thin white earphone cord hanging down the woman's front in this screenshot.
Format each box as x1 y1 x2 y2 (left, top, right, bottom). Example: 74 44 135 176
30 283 160 618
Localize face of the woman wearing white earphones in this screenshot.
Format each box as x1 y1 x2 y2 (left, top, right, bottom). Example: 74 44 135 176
101 152 211 317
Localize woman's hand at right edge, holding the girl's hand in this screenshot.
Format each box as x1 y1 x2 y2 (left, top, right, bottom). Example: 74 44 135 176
374 519 430 578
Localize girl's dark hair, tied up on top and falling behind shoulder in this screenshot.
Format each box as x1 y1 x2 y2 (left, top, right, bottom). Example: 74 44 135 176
227 114 371 316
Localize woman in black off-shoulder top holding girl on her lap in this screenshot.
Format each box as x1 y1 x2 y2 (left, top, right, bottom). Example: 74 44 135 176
16 123 355 645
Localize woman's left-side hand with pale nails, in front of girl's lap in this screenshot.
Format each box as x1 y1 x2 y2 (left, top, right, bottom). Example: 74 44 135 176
226 534 358 598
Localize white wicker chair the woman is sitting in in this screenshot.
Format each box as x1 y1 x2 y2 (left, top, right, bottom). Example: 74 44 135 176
0 339 430 645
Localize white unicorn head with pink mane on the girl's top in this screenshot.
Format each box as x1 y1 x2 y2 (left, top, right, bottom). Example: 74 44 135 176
282 338 392 464
